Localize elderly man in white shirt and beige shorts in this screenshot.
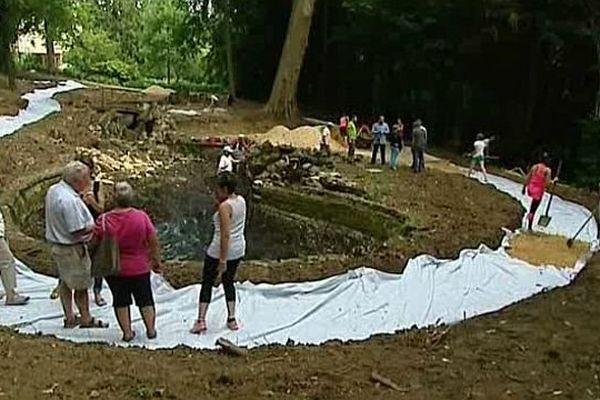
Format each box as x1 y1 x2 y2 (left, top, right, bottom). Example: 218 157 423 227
46 161 108 328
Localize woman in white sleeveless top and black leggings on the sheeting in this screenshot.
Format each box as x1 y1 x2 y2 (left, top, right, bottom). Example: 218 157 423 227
192 173 246 334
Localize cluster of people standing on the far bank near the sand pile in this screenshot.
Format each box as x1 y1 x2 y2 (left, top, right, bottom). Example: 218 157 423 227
339 115 428 173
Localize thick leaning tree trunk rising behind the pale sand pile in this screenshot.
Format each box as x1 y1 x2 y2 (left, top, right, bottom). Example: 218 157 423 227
266 0 316 119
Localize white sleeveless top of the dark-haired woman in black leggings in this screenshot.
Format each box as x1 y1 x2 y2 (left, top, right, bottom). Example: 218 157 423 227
206 195 246 261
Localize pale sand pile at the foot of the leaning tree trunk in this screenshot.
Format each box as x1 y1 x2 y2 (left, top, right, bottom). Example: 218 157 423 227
254 125 344 152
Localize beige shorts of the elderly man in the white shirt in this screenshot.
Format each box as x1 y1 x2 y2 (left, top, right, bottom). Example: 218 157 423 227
52 244 92 290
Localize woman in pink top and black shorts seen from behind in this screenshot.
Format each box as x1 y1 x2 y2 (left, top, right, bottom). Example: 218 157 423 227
92 182 162 342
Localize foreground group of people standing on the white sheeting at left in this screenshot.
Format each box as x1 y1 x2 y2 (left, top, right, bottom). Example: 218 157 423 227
0 155 246 342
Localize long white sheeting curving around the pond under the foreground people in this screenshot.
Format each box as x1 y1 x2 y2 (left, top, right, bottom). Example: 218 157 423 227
0 173 597 349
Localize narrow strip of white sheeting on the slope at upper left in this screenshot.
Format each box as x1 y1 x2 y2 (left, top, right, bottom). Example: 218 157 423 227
0 81 84 137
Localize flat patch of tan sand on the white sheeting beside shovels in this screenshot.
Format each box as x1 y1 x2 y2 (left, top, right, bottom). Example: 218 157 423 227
508 233 589 268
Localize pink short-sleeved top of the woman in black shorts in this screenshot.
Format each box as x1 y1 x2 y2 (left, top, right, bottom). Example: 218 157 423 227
94 208 156 276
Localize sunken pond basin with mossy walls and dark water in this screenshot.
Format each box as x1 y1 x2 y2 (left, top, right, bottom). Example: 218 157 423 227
10 146 410 268
